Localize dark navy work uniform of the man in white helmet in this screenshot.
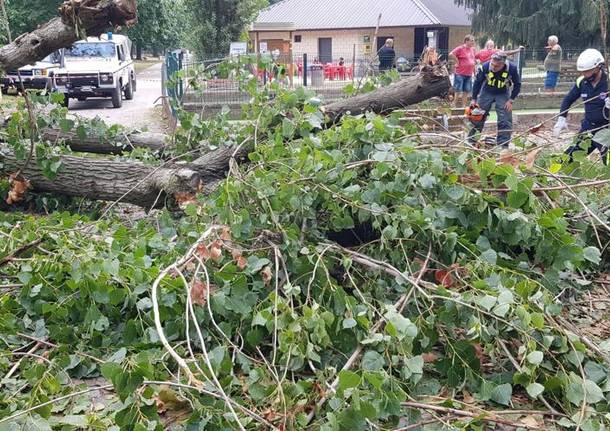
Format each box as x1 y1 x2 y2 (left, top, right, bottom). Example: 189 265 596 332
560 70 610 164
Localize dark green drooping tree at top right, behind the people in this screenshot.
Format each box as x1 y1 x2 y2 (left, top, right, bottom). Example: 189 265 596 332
455 0 608 48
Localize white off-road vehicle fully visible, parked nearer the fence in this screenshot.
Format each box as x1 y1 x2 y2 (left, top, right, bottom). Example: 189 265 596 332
53 33 136 108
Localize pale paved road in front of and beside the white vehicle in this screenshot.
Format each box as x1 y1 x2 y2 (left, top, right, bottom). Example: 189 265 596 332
70 63 165 132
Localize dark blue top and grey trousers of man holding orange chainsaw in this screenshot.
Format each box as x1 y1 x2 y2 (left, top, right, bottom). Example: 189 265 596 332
468 61 521 148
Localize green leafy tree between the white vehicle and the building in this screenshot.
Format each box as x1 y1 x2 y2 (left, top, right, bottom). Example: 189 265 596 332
184 0 269 59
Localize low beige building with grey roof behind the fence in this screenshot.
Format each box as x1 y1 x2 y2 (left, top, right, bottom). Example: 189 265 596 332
250 0 471 63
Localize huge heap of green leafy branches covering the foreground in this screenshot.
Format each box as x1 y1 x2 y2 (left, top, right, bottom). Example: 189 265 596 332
0 1 610 430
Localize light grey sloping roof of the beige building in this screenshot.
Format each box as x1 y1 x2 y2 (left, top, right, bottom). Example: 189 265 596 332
254 0 471 30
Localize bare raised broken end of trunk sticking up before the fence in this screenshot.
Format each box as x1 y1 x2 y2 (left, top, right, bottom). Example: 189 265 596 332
323 65 451 123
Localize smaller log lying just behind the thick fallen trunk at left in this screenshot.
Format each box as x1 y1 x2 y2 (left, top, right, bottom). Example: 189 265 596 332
42 129 171 154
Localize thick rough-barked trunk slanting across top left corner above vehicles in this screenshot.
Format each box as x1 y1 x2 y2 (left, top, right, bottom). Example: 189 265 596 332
0 0 137 71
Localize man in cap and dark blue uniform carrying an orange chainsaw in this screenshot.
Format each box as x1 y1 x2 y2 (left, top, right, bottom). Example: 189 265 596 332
466 51 521 148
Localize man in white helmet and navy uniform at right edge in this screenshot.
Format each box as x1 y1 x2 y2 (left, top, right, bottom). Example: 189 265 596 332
553 49 610 164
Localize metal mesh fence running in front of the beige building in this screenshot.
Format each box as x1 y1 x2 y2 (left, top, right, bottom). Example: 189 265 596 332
164 45 581 116
